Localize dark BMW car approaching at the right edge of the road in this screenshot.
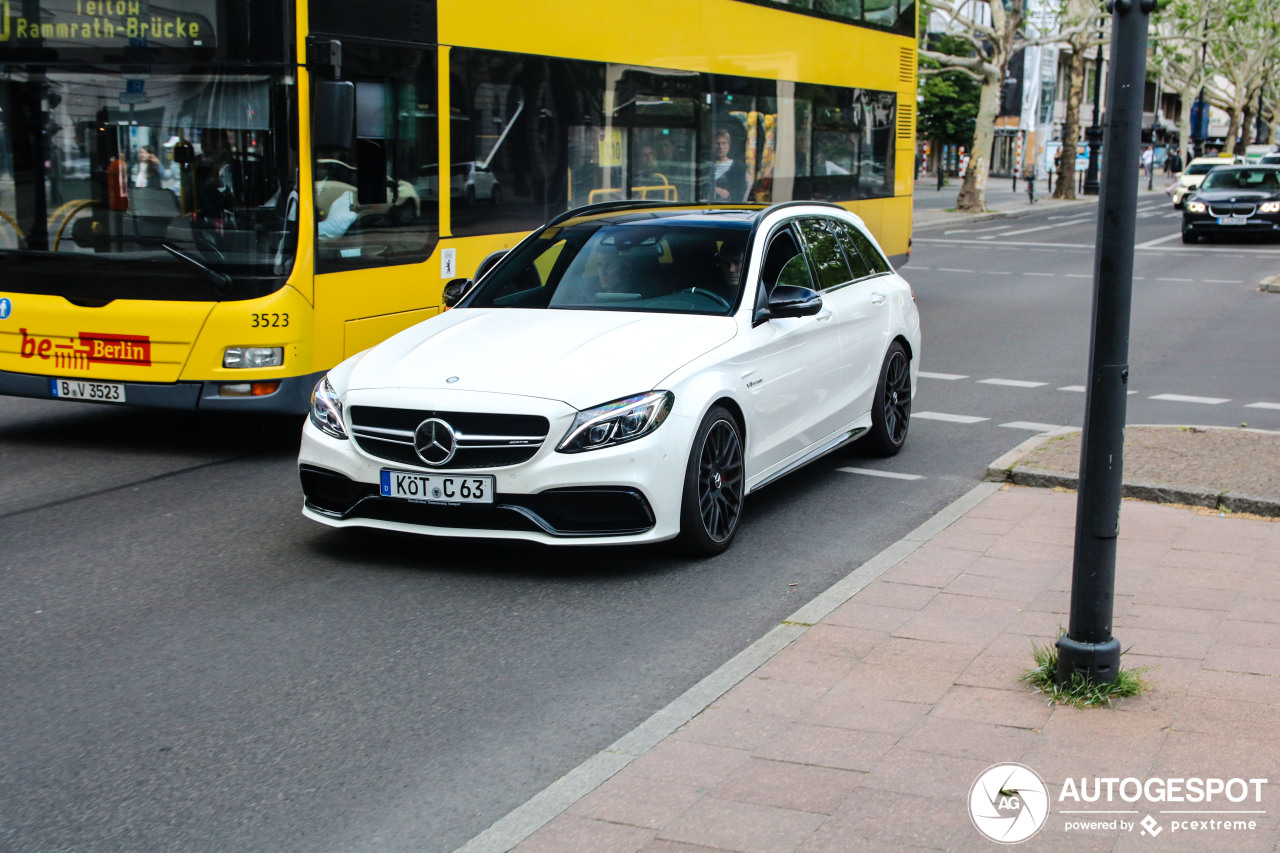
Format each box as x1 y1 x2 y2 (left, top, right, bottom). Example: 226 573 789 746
1183 165 1280 243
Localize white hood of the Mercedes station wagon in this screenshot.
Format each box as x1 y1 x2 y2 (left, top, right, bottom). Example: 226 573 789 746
347 309 737 409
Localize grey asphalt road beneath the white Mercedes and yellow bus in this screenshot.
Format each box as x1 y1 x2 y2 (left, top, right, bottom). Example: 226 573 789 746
0 189 1280 852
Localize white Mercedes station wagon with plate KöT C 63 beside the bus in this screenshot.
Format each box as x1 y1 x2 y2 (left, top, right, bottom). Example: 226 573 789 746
298 201 920 555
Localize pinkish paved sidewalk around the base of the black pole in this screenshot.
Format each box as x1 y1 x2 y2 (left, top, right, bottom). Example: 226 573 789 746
463 428 1280 853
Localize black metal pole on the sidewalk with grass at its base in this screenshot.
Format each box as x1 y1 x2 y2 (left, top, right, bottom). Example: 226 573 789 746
1057 0 1156 684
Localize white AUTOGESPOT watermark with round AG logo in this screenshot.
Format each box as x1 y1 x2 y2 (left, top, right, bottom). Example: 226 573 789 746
969 763 1267 844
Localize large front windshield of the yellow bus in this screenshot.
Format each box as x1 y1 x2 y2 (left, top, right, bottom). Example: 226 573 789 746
0 65 297 300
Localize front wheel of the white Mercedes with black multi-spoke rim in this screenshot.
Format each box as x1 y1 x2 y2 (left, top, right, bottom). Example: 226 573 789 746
678 406 746 557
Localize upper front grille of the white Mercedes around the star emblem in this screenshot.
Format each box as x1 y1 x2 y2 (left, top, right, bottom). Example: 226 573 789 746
351 406 550 470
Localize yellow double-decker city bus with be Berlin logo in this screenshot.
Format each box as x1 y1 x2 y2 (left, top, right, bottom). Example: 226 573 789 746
0 0 916 412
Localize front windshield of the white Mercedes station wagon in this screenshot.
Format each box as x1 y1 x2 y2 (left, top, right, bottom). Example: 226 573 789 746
463 218 750 315
